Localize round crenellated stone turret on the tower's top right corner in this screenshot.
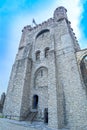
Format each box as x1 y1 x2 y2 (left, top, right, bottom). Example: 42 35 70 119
54 6 67 21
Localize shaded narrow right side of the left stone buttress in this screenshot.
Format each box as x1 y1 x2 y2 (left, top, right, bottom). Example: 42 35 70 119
20 58 32 120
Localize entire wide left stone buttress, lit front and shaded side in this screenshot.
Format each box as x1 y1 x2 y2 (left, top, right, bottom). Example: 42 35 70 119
3 58 31 120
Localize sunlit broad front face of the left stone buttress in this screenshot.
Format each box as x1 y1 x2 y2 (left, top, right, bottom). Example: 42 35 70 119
3 59 26 119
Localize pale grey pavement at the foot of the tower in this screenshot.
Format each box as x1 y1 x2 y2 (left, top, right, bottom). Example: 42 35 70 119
0 118 67 130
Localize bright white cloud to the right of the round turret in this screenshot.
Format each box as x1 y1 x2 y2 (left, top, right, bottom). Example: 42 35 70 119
54 0 82 38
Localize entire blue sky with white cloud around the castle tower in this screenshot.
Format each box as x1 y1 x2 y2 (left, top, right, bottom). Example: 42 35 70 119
0 0 87 95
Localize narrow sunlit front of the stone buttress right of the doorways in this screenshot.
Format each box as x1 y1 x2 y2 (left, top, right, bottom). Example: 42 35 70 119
48 50 58 129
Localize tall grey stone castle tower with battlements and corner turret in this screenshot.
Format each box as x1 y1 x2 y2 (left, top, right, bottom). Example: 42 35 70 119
3 7 87 130
